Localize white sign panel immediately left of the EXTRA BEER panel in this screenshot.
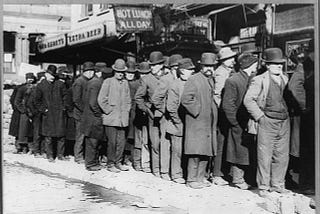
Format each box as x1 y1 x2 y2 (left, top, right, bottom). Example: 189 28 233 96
38 34 66 53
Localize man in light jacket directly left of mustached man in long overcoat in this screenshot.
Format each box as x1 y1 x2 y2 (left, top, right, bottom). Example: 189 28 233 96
166 58 195 184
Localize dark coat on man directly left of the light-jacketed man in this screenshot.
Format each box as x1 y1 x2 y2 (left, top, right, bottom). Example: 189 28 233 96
81 76 105 140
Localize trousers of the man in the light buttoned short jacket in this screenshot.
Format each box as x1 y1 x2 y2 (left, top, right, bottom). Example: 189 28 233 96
105 126 126 167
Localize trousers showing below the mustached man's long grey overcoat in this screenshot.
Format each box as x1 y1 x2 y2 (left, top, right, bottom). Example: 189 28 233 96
187 155 209 182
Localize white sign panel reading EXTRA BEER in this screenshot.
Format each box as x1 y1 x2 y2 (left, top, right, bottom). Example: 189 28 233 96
67 24 105 45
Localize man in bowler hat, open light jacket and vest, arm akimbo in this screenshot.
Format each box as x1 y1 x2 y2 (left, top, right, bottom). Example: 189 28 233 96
244 48 290 197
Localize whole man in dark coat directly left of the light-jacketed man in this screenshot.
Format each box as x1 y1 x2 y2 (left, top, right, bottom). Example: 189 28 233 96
81 62 107 171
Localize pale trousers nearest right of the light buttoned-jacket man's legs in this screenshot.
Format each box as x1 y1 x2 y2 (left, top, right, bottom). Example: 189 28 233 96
133 126 150 169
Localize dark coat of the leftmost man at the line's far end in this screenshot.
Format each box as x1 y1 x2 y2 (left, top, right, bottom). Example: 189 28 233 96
9 84 23 137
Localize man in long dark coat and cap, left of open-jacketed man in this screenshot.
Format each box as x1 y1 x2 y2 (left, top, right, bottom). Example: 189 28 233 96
222 53 258 189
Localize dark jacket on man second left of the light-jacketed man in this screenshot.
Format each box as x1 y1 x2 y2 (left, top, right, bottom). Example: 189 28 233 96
72 75 88 121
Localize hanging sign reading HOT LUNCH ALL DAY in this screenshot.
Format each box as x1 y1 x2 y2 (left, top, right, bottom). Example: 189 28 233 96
114 7 153 33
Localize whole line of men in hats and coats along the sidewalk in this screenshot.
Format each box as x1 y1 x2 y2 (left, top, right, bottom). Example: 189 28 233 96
9 40 314 196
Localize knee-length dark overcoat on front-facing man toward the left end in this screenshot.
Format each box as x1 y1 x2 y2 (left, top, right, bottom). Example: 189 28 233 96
36 80 66 137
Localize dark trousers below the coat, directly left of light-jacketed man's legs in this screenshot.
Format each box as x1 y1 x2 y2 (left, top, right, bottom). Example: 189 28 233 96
84 137 99 168
